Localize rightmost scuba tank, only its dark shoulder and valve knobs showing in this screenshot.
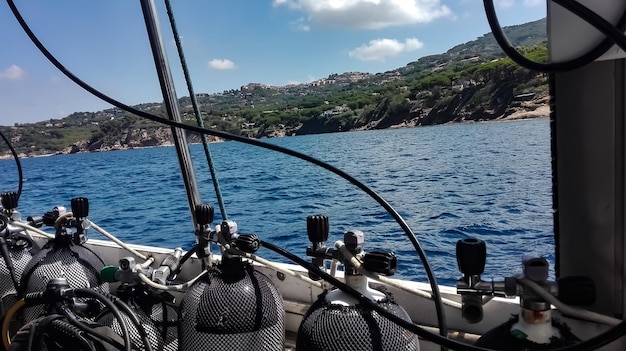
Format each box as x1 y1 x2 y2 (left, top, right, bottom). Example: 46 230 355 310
456 238 595 351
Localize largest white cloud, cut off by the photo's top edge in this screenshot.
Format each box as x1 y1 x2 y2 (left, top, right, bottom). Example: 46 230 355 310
273 0 452 29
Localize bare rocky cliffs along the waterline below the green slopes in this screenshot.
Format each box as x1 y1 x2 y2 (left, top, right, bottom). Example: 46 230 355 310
61 82 549 153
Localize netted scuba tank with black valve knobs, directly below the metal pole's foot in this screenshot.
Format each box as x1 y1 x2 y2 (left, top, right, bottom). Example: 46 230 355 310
178 205 285 351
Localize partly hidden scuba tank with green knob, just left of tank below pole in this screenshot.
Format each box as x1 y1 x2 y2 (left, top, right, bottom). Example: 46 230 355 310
96 253 182 351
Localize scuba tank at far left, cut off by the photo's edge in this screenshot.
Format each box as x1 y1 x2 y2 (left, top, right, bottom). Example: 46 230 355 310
0 192 33 316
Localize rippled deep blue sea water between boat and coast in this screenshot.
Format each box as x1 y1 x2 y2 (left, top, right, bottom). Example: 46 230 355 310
0 119 554 285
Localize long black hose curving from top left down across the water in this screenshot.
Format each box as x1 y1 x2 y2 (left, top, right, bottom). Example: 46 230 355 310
7 0 447 335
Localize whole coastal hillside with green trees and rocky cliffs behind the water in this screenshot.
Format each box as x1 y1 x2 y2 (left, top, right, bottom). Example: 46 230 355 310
0 19 547 156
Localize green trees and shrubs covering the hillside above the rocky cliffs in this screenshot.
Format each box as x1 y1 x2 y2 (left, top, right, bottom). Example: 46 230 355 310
0 19 548 154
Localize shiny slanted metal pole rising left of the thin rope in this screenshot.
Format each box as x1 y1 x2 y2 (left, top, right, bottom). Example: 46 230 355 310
141 0 200 228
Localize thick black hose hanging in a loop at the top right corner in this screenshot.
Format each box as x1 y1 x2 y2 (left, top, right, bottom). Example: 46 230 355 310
483 0 626 73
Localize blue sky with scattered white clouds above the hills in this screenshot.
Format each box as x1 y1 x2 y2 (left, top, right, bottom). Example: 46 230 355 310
0 0 546 126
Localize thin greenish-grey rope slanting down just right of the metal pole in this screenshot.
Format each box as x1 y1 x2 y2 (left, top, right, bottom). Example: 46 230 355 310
165 0 228 221
